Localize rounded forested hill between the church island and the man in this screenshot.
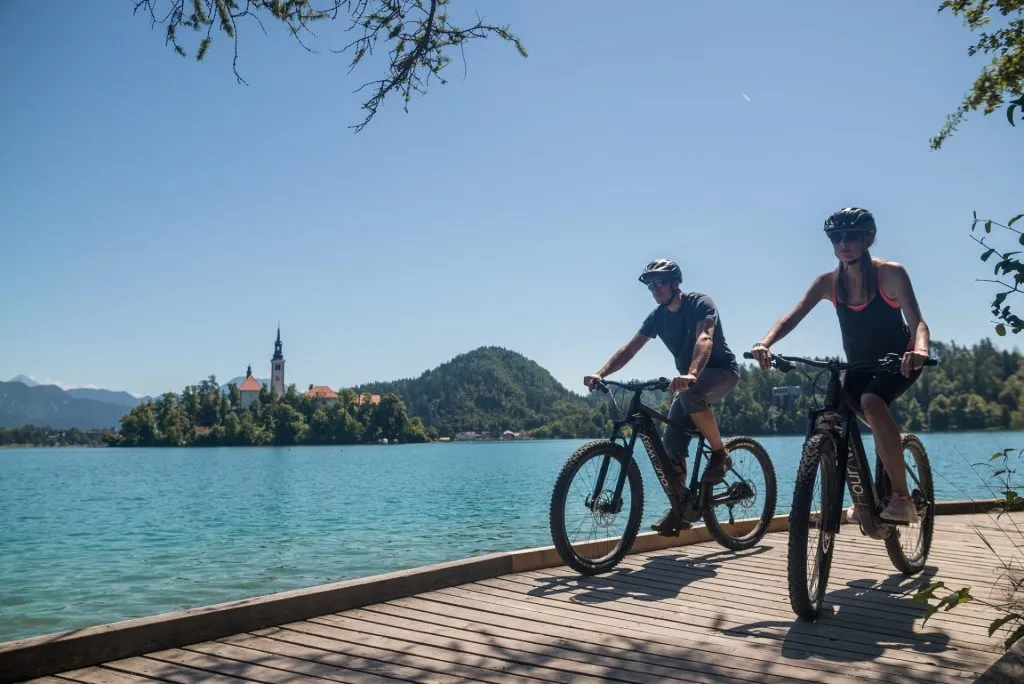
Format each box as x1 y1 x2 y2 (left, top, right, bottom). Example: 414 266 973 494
353 347 593 435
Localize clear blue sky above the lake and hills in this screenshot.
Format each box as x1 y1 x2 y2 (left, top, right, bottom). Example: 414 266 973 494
0 0 1022 393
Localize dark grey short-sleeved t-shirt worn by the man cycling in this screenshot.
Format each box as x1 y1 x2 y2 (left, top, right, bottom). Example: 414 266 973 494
640 292 739 375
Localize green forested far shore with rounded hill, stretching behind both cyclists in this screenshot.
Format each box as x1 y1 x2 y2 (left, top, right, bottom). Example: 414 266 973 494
354 339 1024 437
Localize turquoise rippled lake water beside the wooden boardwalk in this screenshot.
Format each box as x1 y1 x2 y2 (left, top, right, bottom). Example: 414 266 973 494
0 432 1024 641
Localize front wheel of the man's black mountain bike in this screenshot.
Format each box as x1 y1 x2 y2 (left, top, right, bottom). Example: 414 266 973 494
550 439 643 574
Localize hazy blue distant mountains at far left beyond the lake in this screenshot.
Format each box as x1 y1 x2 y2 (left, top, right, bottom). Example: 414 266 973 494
0 382 130 430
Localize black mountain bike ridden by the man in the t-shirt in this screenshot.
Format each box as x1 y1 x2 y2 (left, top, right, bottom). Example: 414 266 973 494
550 378 775 574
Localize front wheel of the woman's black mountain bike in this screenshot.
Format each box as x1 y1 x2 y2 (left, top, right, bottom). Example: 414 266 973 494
786 432 840 622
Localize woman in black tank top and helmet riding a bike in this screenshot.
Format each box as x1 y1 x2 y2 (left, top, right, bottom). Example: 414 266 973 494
751 208 929 522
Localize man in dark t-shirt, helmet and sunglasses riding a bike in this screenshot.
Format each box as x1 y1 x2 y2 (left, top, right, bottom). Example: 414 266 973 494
584 259 739 533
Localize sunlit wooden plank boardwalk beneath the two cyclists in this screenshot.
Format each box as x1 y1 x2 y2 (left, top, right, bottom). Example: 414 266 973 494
8 514 1024 684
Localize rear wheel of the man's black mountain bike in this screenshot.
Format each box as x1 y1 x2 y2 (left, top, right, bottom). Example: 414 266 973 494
703 437 776 551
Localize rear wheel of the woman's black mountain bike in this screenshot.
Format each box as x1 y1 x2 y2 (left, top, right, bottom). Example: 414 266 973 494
884 434 935 575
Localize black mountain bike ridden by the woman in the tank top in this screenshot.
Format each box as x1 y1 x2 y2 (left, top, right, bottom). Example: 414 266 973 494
743 351 938 622
